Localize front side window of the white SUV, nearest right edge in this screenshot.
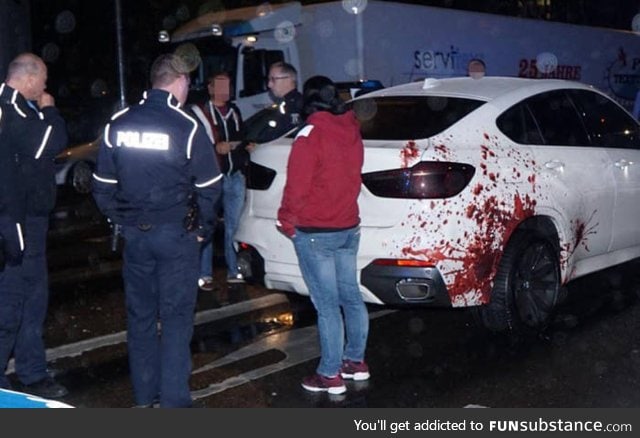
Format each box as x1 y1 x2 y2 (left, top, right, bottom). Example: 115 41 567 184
569 90 640 149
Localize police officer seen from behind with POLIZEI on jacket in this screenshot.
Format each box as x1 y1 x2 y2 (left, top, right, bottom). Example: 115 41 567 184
93 54 222 407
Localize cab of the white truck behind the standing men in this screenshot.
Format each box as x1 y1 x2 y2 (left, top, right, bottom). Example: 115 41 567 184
165 3 301 118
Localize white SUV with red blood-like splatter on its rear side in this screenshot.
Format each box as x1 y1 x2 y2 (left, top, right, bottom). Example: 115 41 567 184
235 77 640 331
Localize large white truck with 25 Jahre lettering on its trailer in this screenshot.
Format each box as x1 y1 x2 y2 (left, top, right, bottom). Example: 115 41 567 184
161 0 640 117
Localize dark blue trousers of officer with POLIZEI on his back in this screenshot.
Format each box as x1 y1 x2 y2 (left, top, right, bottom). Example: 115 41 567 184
122 224 200 407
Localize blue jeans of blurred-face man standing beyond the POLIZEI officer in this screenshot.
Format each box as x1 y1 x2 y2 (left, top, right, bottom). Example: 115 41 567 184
200 172 246 278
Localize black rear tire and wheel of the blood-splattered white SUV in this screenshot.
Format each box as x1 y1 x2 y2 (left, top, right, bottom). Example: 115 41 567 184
475 231 561 335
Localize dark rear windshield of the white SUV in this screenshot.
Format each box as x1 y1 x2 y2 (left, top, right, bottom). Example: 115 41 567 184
351 96 484 140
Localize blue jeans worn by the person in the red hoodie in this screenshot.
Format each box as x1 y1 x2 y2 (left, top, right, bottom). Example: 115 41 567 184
293 227 369 376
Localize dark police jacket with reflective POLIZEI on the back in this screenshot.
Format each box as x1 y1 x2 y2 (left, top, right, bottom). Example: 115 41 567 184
93 89 222 236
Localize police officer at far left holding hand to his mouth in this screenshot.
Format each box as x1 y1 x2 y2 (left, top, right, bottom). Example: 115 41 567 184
0 53 67 398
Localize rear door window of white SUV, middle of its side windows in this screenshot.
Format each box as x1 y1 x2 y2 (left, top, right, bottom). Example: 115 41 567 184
524 90 591 146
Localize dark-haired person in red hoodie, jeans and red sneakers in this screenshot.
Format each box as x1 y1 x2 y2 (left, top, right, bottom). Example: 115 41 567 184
278 76 369 394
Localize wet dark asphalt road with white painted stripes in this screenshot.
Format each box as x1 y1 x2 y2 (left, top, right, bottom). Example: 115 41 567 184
10 188 640 408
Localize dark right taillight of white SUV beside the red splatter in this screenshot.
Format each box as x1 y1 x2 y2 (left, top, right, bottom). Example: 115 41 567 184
362 161 476 199
